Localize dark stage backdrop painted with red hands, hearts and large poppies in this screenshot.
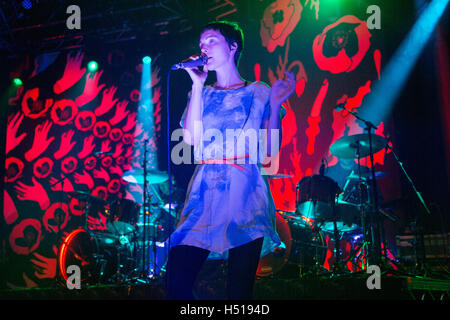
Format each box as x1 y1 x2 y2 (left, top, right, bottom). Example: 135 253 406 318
2 0 446 288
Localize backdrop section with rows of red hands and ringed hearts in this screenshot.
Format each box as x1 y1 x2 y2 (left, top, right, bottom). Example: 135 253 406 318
3 51 161 288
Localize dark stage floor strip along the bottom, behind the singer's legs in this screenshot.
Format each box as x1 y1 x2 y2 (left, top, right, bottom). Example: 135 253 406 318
0 272 450 301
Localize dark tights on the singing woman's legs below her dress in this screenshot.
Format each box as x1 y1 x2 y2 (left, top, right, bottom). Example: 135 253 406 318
167 238 263 300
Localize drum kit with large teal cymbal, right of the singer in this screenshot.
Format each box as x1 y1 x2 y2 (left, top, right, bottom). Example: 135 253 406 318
257 134 388 277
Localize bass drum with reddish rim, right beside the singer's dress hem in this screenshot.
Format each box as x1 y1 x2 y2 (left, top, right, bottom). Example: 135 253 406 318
256 212 327 277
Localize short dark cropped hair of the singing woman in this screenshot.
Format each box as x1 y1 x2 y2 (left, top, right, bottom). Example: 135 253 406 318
201 20 244 66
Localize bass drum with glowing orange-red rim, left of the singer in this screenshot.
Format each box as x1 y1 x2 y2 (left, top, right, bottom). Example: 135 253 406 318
58 229 135 285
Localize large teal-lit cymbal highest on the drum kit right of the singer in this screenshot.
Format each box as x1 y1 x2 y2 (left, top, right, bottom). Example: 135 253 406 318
330 133 387 159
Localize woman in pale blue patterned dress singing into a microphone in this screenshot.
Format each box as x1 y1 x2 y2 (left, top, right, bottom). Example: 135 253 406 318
167 21 295 300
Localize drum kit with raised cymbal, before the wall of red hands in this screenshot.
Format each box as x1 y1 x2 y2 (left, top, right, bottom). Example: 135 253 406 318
58 170 176 285
